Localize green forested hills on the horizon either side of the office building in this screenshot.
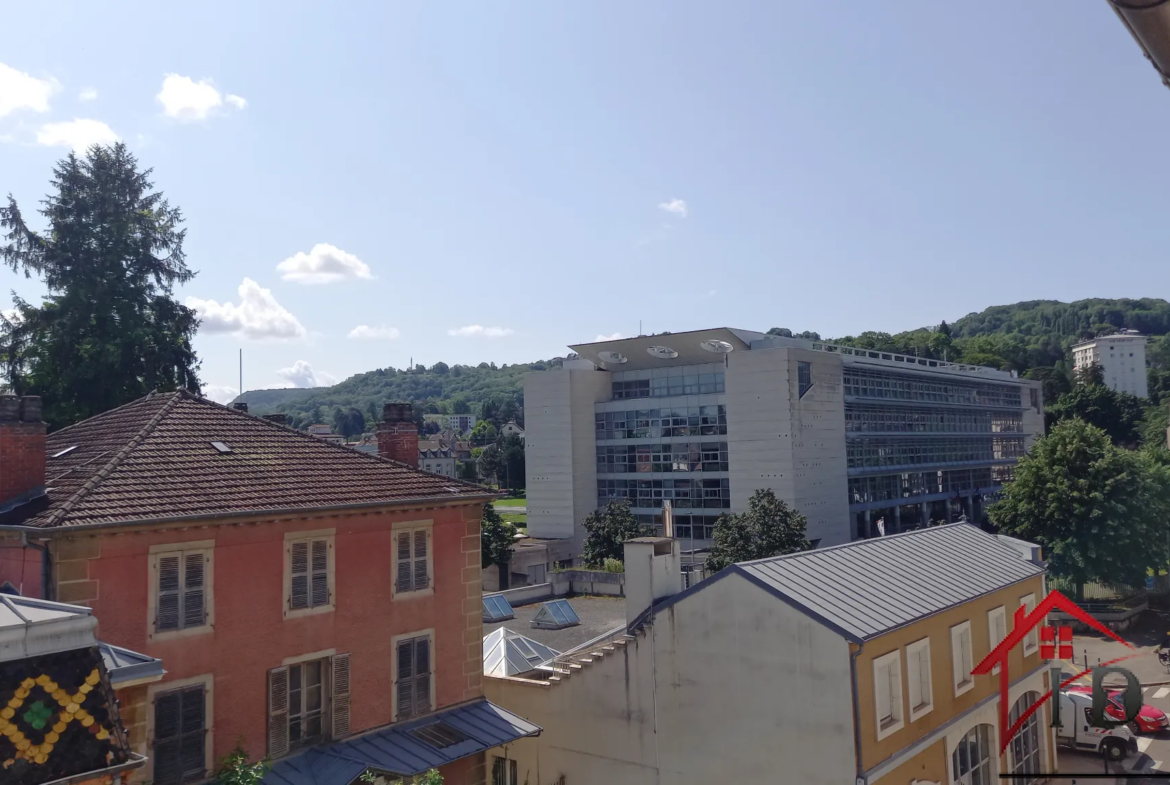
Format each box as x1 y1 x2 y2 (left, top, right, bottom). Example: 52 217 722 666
236 298 1170 426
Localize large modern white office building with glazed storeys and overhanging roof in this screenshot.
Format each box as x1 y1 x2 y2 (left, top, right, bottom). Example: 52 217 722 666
524 328 1044 552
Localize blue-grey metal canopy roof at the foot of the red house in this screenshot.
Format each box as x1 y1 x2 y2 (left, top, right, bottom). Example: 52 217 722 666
264 701 541 785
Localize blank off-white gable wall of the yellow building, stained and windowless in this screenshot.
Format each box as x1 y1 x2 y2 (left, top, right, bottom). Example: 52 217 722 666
484 574 855 785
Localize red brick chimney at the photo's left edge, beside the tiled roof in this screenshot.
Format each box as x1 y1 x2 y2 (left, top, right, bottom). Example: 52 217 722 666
0 395 46 509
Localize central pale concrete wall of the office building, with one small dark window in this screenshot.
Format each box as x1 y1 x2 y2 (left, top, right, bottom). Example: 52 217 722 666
725 346 851 545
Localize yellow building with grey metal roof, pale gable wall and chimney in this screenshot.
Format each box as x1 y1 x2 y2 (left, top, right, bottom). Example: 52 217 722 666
484 523 1055 785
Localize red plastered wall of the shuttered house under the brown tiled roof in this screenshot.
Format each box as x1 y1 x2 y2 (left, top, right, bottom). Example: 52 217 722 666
10 504 483 760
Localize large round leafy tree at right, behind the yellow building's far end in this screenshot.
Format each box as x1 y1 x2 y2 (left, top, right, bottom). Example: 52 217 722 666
987 419 1170 599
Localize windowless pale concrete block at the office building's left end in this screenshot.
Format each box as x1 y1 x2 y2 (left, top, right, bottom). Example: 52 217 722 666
524 369 611 540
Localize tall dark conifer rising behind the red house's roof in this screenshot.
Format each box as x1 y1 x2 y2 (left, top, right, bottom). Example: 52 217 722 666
0 143 200 427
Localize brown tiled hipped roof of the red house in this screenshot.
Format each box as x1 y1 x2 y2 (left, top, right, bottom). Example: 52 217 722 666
29 392 491 528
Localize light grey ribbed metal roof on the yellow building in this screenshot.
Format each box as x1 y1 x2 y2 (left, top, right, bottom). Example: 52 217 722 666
734 523 1044 641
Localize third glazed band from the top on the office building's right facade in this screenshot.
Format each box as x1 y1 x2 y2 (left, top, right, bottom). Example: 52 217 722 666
845 436 1024 469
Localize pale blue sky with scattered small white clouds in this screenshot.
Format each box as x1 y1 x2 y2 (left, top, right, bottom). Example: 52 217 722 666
0 0 1170 404
